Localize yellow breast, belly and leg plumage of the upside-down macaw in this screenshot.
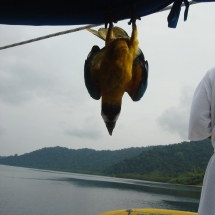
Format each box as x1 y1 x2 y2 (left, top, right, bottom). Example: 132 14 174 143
91 24 138 105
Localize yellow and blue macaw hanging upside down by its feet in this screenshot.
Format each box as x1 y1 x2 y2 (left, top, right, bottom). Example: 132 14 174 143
84 23 148 135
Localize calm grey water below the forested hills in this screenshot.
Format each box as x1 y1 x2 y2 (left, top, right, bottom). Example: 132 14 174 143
0 165 201 215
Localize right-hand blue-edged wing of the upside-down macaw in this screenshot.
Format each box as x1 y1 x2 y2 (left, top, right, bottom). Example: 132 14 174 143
126 49 148 101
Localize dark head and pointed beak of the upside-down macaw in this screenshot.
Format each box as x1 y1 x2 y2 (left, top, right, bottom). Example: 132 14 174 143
101 103 121 135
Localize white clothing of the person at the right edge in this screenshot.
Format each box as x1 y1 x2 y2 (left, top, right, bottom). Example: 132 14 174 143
188 68 215 215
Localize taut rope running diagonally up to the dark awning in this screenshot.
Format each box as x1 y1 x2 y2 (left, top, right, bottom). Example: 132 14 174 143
0 1 200 50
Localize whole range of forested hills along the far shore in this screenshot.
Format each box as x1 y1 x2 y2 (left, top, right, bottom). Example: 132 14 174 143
0 139 214 184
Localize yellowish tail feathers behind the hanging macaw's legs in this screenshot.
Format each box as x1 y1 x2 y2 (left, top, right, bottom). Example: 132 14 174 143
87 27 129 40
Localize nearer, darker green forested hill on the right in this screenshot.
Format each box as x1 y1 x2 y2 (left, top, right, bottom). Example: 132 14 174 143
104 139 214 184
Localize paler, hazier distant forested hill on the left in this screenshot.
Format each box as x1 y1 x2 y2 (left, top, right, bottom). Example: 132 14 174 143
0 147 148 173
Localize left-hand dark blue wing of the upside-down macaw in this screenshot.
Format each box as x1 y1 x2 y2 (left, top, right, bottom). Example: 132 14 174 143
84 46 104 100
